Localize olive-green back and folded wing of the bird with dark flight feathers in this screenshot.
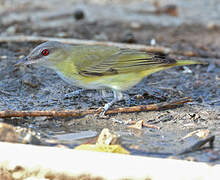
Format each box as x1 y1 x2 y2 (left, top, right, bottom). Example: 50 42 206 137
73 46 176 76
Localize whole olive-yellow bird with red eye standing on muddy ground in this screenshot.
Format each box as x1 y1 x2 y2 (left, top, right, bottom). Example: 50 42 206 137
16 41 201 114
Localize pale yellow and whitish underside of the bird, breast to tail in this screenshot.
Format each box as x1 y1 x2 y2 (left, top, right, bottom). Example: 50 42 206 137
53 61 175 91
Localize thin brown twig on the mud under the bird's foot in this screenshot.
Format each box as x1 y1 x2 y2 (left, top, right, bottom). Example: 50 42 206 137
0 97 192 118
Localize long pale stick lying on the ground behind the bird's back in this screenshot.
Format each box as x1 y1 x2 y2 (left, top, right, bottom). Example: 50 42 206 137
0 36 171 54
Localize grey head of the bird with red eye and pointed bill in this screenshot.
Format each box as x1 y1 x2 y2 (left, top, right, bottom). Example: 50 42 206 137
15 41 68 67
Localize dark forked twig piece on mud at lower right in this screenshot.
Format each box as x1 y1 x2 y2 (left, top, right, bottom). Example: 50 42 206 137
179 136 215 155
